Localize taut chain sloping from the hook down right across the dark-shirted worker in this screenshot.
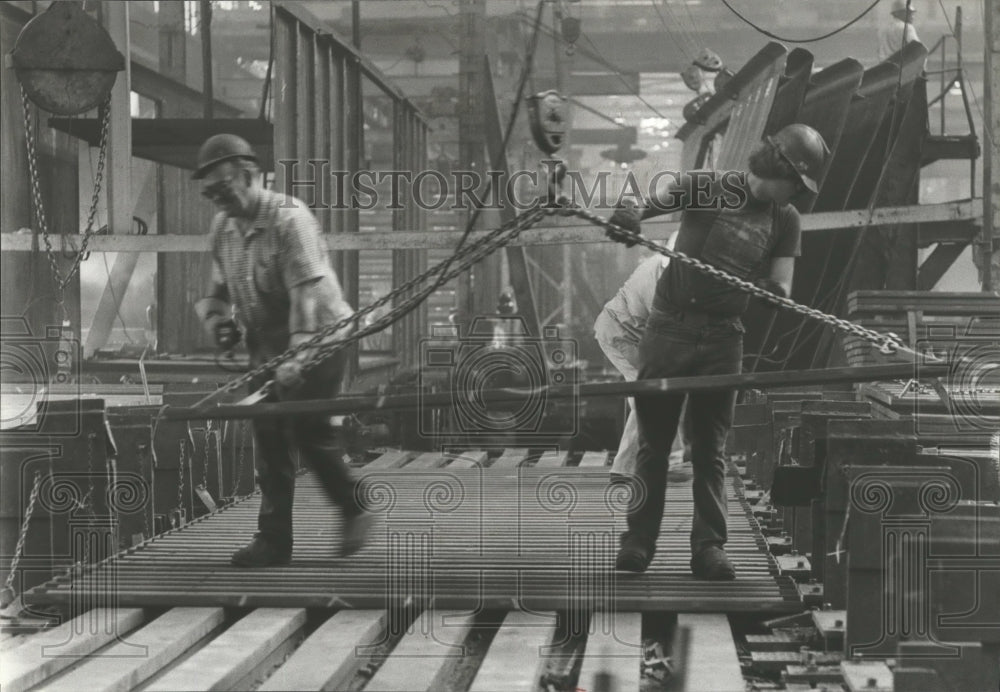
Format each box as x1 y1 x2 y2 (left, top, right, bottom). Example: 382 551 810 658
556 207 910 355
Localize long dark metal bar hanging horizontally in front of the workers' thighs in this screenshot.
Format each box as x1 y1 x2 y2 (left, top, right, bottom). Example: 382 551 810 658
164 363 949 420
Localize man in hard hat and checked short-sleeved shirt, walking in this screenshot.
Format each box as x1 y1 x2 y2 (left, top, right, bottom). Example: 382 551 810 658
194 134 373 567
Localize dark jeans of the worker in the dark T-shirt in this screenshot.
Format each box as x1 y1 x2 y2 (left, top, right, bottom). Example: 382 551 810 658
628 309 744 553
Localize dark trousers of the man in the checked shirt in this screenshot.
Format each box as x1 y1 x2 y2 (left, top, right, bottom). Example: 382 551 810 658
250 351 361 549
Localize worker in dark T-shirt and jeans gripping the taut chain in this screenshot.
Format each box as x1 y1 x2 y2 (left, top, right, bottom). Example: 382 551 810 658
608 124 829 580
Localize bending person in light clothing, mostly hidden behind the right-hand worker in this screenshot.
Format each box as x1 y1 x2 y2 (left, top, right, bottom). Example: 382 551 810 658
594 233 691 480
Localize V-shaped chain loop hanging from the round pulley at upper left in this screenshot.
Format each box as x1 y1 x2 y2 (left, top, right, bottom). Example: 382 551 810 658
21 85 111 305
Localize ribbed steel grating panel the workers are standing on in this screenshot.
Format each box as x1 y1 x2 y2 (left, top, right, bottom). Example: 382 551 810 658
25 468 801 613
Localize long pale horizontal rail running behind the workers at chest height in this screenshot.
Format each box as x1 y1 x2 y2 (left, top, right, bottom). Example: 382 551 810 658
0 200 983 252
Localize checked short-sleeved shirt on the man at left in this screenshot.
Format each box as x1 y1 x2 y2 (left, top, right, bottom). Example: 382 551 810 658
210 190 353 346
